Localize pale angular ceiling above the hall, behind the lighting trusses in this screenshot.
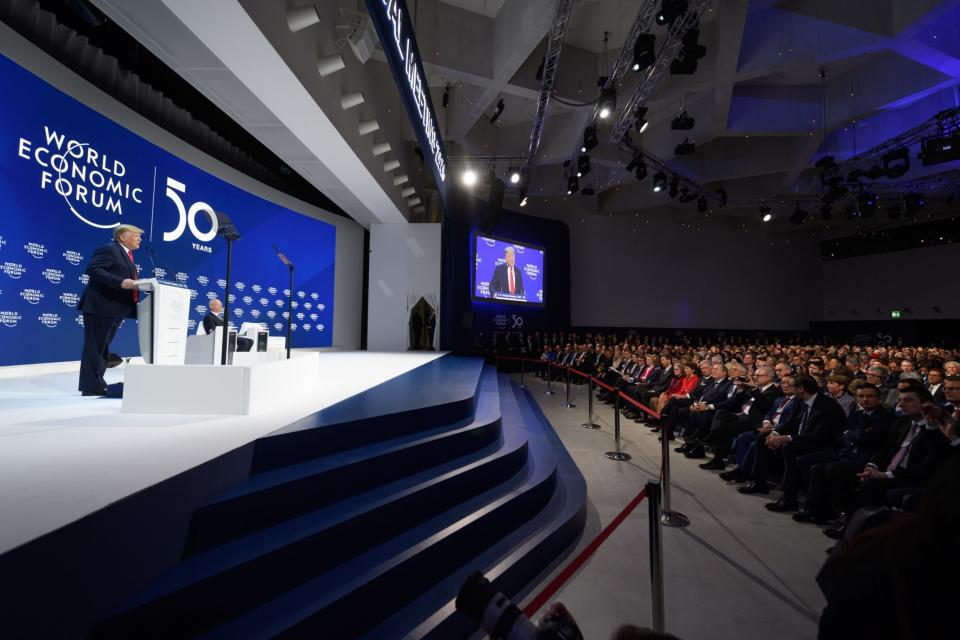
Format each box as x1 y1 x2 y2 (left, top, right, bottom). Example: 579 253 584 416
95 0 960 236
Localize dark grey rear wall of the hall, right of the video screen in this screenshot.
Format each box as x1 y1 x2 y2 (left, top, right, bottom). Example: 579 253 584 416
524 196 822 330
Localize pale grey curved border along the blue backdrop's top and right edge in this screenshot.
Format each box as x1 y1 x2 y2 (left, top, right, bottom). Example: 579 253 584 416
0 23 364 349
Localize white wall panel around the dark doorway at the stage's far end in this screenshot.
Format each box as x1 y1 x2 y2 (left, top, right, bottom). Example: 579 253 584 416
367 224 441 351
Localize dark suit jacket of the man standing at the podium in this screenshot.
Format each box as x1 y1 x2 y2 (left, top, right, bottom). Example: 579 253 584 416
77 242 137 318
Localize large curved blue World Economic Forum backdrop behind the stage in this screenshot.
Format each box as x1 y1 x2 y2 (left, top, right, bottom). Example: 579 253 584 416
0 56 336 365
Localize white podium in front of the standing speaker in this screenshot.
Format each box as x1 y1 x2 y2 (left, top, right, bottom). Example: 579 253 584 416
133 278 190 365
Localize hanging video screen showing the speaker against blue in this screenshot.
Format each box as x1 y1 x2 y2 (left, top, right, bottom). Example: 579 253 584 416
473 234 546 305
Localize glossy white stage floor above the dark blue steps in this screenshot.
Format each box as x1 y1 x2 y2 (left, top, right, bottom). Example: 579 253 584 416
0 351 443 554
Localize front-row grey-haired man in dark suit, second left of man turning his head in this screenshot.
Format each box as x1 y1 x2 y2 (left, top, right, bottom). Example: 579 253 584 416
700 366 783 471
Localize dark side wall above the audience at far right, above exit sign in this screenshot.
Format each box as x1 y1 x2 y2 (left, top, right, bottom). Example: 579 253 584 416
823 244 960 320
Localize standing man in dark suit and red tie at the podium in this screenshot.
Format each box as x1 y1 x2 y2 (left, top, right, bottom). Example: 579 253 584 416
77 224 143 396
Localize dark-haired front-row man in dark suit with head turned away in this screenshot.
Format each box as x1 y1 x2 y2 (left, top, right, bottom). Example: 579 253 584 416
738 375 847 512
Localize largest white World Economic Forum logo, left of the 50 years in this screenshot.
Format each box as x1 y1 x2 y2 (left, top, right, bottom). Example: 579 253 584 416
17 125 144 229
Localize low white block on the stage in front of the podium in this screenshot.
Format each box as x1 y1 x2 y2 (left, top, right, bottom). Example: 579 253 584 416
122 351 320 415
